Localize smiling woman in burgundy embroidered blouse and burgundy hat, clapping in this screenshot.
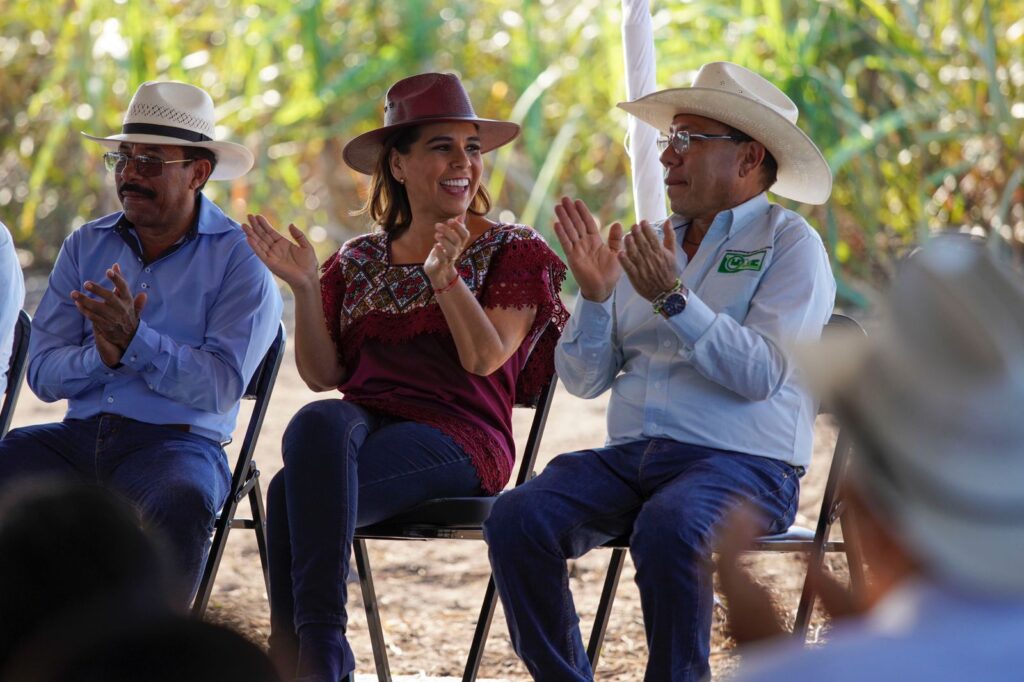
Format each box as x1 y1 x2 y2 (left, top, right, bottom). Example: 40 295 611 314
246 74 568 682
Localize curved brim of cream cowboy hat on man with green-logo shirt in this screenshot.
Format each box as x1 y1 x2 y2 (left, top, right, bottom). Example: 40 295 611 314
618 87 833 204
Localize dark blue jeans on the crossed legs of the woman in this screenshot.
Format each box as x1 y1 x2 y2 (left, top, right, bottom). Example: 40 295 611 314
267 399 485 682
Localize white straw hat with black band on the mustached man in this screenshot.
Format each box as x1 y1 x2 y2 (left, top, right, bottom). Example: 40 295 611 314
82 81 253 180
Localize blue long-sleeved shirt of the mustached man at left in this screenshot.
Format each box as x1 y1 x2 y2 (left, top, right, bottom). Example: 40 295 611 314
29 196 282 441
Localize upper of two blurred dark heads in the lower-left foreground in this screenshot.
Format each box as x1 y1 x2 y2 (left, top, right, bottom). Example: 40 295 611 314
0 478 171 679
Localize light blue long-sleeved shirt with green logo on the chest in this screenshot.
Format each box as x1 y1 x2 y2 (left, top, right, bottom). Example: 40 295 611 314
555 194 836 467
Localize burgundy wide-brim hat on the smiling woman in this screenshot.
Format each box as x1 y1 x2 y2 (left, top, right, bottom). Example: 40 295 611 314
342 74 519 175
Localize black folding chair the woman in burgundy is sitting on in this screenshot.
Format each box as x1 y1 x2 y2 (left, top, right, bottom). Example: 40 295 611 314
352 377 557 682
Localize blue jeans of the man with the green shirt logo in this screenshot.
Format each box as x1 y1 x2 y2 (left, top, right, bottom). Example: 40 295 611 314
483 439 800 682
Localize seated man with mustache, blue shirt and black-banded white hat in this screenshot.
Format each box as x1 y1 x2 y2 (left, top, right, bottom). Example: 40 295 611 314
0 82 282 595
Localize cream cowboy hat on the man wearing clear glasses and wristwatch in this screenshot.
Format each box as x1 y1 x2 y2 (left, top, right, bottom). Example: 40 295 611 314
618 61 831 204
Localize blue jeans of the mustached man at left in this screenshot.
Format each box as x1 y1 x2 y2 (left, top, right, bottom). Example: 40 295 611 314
0 415 231 604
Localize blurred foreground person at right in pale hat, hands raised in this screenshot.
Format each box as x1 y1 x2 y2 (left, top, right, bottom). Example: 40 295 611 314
720 232 1024 682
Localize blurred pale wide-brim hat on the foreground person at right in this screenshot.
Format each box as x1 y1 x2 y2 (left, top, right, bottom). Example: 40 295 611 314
804 236 1024 597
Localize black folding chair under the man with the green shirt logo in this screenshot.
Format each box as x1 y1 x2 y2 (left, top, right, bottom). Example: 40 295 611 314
587 313 864 672
